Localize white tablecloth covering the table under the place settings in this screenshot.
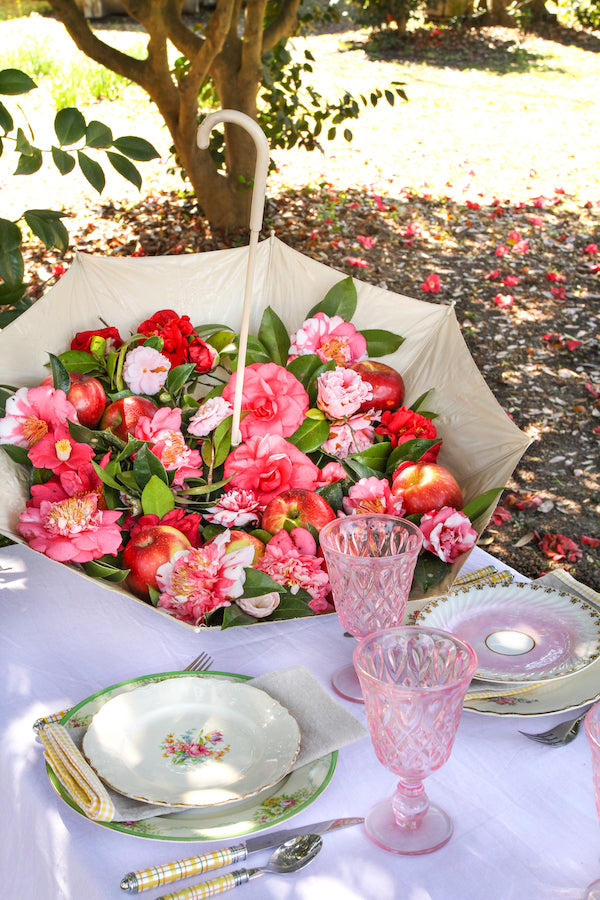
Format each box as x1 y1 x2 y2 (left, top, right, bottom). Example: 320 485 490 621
0 547 600 900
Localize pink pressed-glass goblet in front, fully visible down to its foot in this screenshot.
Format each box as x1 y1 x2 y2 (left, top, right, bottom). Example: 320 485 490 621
354 625 477 855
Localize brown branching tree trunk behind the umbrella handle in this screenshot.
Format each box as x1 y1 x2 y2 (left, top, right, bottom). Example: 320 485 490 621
44 0 300 230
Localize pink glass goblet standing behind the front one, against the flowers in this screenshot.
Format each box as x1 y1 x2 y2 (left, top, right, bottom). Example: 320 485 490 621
319 513 423 703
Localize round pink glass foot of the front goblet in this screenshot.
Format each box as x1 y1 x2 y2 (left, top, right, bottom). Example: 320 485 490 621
365 798 452 856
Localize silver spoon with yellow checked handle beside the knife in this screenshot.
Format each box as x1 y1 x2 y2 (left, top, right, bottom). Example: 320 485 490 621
157 834 323 900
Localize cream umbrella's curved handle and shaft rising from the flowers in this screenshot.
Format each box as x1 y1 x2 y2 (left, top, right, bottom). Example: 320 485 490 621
196 109 269 447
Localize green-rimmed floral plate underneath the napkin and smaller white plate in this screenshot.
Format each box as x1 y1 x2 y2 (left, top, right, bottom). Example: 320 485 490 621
46 672 338 841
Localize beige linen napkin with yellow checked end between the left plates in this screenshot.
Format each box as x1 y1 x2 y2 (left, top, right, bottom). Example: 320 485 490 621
38 666 368 822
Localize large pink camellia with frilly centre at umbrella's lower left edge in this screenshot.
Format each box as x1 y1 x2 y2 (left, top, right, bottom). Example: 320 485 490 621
17 480 121 563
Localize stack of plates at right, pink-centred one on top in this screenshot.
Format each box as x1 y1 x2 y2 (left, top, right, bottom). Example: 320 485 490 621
417 583 600 715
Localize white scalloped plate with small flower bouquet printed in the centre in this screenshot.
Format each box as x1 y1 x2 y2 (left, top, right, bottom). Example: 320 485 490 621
83 676 300 807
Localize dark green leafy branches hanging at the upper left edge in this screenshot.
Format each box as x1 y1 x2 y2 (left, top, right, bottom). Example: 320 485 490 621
0 68 158 328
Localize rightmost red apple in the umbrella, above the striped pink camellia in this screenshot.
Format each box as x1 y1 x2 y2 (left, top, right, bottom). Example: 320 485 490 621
392 462 464 515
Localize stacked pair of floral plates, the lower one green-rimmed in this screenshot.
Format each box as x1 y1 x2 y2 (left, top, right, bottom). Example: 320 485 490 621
49 672 337 841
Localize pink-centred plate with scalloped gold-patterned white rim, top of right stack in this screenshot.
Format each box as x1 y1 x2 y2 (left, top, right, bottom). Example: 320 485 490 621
417 583 600 684
